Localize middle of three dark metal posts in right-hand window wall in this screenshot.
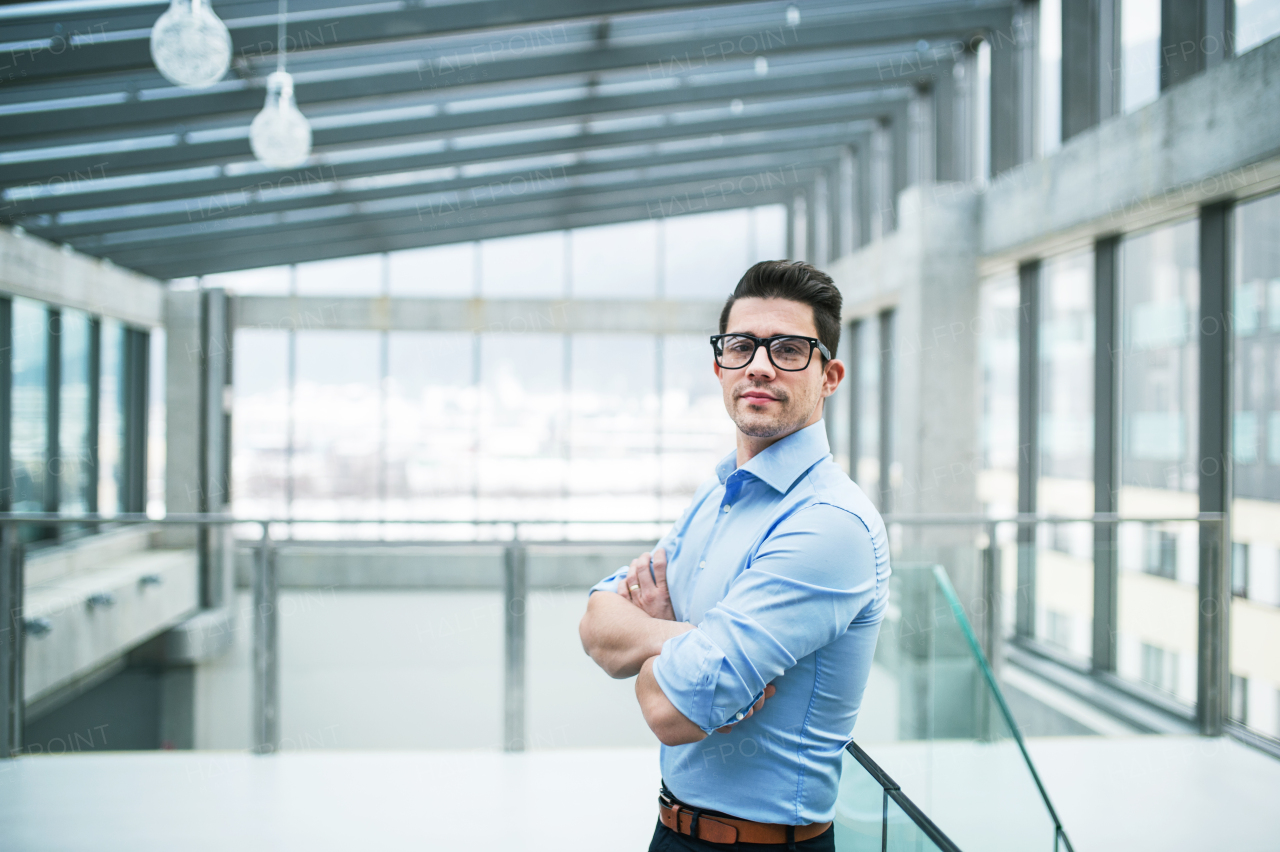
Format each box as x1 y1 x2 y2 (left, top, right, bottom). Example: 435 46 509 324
1092 237 1120 672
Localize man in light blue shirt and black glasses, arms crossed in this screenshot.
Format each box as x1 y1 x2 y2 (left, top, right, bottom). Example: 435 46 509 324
579 261 890 852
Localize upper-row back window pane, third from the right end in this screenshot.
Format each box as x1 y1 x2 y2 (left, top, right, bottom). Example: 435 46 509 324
570 220 658 299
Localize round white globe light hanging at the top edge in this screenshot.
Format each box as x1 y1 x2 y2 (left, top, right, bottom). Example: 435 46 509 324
151 0 232 88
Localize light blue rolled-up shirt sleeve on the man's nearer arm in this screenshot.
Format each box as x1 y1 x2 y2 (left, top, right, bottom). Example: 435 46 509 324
653 503 876 733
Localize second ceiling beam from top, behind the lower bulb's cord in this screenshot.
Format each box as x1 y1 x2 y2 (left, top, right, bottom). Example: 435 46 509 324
0 6 1011 139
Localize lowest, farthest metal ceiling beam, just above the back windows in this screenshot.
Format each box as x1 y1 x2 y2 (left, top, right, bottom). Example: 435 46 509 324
92 163 829 278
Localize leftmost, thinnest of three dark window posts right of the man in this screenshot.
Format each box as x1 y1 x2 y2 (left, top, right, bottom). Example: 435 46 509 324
1015 260 1041 638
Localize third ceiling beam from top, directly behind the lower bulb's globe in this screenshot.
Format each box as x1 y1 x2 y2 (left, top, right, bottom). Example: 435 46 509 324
0 60 951 187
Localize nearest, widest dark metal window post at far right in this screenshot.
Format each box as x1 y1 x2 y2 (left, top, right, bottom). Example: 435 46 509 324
1196 202 1233 737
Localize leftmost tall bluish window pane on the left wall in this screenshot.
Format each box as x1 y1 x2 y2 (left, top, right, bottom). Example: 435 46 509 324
10 298 49 540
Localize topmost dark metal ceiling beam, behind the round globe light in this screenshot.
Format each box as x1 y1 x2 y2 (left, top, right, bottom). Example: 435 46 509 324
0 0 742 81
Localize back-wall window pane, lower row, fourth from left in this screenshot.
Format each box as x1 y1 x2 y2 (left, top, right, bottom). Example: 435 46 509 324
479 334 567 518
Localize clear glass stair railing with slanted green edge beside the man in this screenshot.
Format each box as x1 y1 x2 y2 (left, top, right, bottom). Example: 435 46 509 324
836 564 1071 852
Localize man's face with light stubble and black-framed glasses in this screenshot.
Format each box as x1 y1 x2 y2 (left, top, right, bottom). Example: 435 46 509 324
716 298 845 438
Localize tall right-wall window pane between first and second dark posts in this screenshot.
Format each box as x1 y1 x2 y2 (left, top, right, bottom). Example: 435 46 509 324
1036 251 1094 660
